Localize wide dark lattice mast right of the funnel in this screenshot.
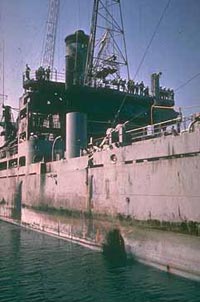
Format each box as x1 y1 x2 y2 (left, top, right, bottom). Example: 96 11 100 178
84 0 130 85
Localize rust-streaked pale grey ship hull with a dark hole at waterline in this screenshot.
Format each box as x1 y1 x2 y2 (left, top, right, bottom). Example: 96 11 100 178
0 127 200 279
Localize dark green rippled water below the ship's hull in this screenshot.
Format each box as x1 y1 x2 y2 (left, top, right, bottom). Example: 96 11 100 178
0 222 200 302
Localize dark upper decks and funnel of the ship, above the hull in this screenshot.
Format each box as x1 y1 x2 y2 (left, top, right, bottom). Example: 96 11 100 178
1 26 178 167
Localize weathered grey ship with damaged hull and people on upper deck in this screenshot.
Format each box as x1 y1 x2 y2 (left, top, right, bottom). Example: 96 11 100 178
0 1 200 280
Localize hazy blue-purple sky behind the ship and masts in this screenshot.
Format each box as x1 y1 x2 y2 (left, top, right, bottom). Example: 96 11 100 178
0 0 200 115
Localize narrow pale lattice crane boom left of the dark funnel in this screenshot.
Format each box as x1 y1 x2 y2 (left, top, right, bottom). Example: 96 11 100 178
41 0 60 70
